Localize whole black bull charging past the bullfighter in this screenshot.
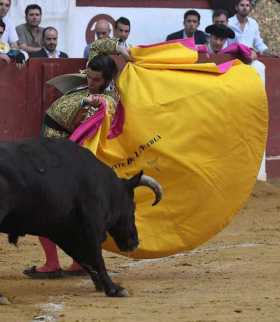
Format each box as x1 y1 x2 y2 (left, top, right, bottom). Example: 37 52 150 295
0 139 161 296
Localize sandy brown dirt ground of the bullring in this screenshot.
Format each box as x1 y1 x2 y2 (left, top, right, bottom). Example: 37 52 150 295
0 182 280 322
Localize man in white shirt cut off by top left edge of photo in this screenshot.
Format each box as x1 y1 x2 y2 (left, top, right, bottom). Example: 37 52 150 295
0 0 18 48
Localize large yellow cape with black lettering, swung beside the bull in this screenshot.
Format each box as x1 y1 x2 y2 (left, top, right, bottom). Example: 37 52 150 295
84 43 268 258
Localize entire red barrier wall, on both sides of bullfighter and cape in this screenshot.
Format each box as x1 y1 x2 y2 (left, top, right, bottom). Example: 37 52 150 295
0 58 280 178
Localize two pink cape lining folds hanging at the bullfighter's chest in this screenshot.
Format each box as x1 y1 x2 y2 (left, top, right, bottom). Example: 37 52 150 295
69 99 124 144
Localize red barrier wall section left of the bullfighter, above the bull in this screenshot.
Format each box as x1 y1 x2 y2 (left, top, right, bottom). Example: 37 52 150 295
0 59 85 140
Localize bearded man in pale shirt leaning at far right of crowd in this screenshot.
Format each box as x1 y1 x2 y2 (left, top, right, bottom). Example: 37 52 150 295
229 0 268 55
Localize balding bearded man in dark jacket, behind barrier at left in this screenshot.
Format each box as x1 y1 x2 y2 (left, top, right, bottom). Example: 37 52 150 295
30 27 68 58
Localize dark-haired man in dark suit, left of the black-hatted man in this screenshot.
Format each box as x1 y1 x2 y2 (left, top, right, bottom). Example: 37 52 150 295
166 10 207 45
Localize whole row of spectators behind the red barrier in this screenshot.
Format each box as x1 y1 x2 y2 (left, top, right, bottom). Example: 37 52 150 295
0 0 276 70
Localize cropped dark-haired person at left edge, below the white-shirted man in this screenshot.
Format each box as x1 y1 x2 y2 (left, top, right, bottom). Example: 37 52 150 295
0 19 25 68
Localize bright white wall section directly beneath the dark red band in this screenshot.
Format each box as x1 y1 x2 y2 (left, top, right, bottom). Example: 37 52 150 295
68 2 211 56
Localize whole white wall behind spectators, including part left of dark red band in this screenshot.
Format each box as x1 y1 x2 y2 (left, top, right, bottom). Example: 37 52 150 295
10 0 211 57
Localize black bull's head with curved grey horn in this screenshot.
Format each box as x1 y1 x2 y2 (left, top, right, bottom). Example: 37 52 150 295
109 171 162 252
